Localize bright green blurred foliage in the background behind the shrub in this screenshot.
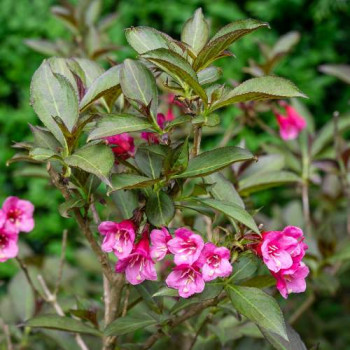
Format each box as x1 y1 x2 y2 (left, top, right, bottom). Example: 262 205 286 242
0 0 350 348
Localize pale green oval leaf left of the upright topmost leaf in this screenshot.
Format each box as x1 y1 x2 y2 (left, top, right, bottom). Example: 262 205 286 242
125 26 172 54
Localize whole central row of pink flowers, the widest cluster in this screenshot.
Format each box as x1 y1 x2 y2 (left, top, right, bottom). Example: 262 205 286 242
98 224 232 298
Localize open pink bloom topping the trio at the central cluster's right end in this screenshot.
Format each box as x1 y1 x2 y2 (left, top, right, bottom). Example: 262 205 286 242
168 228 204 265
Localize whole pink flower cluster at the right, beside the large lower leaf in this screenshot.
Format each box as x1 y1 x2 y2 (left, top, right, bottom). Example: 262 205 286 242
256 226 309 298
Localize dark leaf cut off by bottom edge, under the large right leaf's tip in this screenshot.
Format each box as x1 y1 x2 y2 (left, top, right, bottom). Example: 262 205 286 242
259 324 307 350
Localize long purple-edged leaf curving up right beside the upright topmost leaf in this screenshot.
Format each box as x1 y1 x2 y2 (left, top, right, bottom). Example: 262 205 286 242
193 19 268 71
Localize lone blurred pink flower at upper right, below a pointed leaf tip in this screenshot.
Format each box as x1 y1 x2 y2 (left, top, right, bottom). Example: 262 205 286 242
275 105 306 140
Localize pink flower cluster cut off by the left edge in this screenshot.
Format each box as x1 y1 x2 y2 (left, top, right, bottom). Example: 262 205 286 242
0 197 34 262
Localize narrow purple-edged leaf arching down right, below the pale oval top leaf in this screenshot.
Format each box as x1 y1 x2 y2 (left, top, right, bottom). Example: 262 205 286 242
142 49 208 104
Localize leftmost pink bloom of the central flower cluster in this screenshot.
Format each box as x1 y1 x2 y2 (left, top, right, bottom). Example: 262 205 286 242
98 220 135 259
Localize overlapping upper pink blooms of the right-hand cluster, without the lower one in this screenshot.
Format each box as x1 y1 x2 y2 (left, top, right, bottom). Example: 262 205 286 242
257 226 307 272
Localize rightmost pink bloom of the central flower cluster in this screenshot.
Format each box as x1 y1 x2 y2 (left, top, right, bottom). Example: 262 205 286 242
198 243 232 282
